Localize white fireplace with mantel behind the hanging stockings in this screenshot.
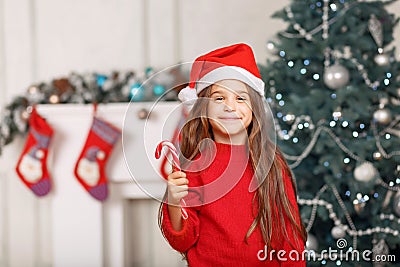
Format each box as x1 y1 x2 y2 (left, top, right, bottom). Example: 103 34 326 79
33 102 185 267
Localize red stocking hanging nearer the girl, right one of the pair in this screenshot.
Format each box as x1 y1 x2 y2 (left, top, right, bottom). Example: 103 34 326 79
74 116 121 201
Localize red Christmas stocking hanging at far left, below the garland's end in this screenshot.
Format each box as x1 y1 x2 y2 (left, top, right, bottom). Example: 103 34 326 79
16 107 53 196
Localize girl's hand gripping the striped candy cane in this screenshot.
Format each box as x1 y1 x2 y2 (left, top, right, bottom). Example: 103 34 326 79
167 171 189 206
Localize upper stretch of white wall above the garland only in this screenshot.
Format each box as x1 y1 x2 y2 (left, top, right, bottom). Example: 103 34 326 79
0 0 288 105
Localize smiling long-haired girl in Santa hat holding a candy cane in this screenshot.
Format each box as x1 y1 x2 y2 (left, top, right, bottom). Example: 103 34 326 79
159 44 306 267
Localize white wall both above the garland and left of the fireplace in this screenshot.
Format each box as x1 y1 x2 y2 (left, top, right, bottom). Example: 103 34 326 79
0 0 400 267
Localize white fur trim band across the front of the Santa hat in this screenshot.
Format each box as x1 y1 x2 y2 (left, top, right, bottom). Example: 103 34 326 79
196 66 265 97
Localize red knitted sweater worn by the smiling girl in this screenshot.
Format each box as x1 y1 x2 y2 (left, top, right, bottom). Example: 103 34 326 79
162 143 305 267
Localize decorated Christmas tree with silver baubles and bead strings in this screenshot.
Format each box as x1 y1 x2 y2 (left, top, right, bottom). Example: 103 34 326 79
261 0 400 266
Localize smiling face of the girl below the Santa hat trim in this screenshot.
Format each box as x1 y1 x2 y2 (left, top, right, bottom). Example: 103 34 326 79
207 80 253 144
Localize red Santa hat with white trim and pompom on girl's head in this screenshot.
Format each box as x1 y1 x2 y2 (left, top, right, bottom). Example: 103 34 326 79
178 43 265 109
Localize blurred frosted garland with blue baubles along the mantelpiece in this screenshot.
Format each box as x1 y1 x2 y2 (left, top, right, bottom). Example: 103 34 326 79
0 67 187 155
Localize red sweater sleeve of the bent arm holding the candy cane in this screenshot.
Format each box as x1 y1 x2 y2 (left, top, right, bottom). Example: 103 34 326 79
161 173 201 253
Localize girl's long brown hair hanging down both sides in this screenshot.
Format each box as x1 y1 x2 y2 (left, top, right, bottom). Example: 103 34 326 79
159 86 307 251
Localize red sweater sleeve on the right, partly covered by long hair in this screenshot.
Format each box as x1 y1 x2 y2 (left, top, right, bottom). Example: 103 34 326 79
281 172 306 267
